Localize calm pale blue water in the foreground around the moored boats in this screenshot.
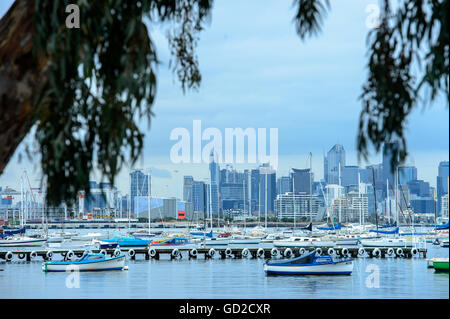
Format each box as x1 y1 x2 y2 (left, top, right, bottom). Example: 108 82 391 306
0 230 449 299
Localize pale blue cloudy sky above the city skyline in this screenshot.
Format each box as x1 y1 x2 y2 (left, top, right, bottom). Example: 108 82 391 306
0 0 449 198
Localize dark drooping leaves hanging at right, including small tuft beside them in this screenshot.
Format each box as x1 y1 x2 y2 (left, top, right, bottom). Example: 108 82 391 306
295 0 449 169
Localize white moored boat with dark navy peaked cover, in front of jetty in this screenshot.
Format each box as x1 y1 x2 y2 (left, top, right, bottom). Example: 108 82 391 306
264 250 353 275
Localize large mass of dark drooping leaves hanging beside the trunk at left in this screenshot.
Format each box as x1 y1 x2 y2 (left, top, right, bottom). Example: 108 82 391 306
33 0 211 204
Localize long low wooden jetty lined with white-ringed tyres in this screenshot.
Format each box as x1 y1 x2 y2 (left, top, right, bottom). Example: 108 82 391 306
0 246 427 262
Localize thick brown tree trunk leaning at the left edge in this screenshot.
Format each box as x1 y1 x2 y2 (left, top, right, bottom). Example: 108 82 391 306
0 0 46 174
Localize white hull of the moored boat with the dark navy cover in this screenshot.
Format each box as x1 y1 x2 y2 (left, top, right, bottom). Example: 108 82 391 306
264 261 353 275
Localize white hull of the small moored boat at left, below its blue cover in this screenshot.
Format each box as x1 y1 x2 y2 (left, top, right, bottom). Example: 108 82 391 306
42 256 125 272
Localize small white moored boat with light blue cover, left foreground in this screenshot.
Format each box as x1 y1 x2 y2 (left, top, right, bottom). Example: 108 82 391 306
42 254 125 272
